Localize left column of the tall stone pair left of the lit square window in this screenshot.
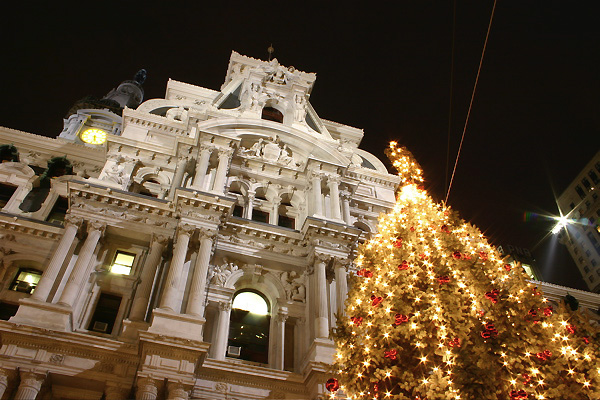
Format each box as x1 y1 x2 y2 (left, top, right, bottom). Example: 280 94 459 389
31 214 83 301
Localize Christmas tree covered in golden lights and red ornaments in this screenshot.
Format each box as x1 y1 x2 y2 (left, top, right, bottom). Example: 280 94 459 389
326 142 600 400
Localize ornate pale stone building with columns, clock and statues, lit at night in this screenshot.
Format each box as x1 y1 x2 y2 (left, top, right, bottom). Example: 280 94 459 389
0 52 399 400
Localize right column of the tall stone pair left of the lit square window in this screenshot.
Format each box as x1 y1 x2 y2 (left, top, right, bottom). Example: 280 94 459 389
58 221 106 307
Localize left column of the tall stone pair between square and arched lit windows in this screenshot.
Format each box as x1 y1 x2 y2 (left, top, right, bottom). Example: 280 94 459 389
160 225 195 312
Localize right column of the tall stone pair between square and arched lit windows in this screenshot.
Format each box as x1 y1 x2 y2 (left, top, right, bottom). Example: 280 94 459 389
186 229 215 317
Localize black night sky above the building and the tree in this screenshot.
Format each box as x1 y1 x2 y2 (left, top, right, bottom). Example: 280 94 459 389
0 0 600 288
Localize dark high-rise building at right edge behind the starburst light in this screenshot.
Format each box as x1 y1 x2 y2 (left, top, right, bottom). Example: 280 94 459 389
557 151 600 293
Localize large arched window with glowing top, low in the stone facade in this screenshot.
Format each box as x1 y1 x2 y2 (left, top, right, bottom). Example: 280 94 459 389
227 290 271 364
